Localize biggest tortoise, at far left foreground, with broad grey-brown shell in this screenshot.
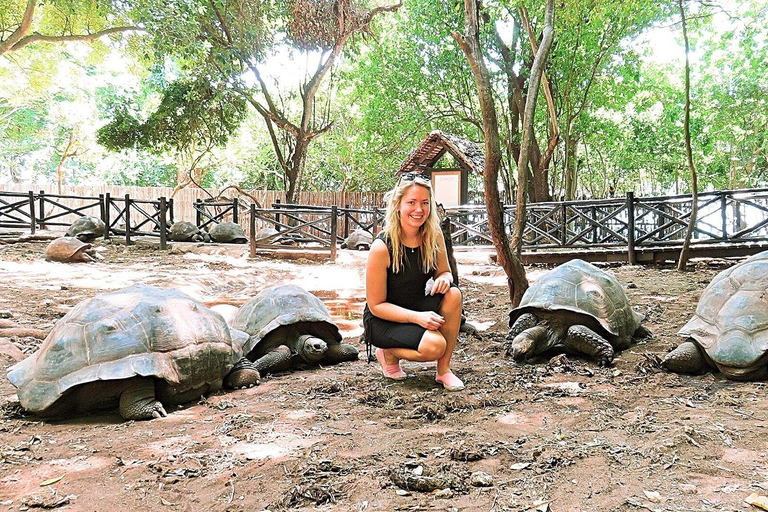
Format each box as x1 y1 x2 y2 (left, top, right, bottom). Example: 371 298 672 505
8 284 259 420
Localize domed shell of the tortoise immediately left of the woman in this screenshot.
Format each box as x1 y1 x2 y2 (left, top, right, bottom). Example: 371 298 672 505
232 284 342 359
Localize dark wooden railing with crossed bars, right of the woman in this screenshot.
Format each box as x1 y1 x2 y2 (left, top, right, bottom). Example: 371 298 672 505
446 189 768 261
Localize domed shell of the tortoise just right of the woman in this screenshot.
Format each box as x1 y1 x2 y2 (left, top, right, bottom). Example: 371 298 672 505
509 259 643 348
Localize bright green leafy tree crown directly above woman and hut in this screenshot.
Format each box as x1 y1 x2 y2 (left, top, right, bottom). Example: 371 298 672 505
336 0 481 186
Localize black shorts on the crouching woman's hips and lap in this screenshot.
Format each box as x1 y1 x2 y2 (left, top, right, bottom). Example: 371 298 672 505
363 294 443 350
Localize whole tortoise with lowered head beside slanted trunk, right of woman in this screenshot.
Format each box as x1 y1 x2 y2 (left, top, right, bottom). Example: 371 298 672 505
505 259 650 366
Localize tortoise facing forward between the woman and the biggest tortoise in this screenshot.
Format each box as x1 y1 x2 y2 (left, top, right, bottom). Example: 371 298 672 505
232 285 358 373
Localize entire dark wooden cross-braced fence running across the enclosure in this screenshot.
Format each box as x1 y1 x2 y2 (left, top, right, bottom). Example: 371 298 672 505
0 185 768 262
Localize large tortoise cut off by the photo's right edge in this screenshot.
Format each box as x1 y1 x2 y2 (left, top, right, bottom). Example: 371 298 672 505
661 251 768 380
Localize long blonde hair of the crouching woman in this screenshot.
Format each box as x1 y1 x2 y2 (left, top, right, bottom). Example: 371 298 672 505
384 179 443 273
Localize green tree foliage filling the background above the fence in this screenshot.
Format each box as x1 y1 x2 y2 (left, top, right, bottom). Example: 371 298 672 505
0 0 768 196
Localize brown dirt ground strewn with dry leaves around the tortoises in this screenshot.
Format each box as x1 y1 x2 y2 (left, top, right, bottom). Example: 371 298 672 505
0 237 768 512
